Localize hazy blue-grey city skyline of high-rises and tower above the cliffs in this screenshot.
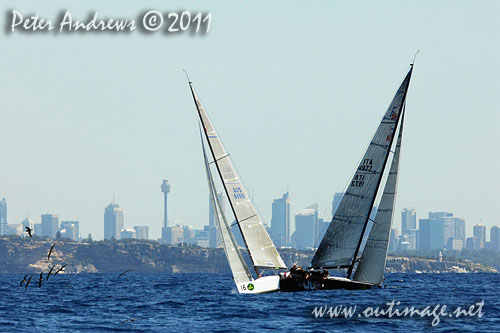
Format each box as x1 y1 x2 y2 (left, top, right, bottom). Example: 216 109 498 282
0 188 500 250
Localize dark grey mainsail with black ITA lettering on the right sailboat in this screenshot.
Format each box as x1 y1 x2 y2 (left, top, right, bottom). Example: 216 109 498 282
311 65 413 270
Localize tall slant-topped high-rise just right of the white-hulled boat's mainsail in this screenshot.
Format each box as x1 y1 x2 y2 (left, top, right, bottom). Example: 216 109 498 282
271 192 290 247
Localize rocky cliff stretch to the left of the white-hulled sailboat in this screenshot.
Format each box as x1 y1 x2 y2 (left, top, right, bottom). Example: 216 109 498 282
0 238 229 274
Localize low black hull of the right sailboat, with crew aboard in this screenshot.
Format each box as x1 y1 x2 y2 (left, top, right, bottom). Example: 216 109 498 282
280 277 374 292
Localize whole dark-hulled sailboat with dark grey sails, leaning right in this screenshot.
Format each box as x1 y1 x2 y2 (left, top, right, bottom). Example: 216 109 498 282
280 64 413 291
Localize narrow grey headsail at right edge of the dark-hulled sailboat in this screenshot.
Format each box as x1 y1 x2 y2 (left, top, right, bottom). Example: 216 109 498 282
354 109 404 286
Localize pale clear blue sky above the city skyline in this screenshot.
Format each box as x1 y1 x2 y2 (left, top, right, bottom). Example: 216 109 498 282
0 0 500 239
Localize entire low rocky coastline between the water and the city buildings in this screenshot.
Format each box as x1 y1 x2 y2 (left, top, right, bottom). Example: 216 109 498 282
0 237 499 274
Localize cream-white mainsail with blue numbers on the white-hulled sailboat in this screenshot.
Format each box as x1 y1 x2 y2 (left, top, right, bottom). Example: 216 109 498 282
189 82 286 269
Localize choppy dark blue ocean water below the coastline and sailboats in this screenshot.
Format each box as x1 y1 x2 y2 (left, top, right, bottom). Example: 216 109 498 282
0 272 500 332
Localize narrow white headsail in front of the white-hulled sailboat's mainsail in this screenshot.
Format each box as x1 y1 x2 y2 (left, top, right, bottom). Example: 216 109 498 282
200 133 253 284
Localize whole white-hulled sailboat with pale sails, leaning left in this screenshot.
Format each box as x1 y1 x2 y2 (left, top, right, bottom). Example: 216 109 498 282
189 76 287 294
